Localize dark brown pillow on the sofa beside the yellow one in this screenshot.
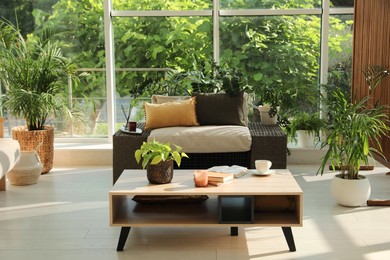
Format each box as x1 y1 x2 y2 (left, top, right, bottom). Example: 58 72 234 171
192 93 245 126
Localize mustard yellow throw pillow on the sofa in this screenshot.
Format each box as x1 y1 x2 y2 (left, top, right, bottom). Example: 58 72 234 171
144 98 199 129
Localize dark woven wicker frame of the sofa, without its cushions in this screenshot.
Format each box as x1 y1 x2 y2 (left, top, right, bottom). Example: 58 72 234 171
113 122 287 183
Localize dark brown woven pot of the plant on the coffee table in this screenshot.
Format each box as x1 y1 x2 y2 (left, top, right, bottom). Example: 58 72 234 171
146 160 173 184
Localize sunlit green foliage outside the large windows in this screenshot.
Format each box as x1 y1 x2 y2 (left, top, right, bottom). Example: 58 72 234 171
0 0 352 137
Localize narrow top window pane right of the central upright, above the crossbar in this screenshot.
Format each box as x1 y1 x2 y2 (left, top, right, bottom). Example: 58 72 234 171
220 0 321 9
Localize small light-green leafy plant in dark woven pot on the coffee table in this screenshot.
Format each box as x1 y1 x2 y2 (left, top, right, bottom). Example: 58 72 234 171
134 140 188 184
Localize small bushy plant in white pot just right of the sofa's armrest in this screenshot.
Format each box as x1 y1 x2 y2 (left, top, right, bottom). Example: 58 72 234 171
287 112 325 148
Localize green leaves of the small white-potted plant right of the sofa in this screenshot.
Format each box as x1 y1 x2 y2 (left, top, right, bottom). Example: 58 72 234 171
287 112 326 143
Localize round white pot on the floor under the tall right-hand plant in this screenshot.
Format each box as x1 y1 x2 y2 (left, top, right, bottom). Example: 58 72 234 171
331 175 371 207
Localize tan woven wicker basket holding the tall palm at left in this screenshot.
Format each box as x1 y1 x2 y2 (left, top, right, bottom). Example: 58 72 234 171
12 126 54 174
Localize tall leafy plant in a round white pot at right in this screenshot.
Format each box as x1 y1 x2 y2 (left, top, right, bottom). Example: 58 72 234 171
317 70 390 206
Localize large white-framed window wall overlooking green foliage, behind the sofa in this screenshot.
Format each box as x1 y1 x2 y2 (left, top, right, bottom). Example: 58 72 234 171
0 0 353 142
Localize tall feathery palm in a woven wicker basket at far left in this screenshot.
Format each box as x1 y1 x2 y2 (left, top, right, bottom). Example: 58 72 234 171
0 22 76 173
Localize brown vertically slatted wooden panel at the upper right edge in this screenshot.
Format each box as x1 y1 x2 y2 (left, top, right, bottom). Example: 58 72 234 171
352 0 390 166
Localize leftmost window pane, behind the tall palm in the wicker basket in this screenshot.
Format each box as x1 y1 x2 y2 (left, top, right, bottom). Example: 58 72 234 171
0 0 107 137
